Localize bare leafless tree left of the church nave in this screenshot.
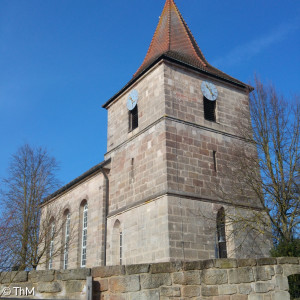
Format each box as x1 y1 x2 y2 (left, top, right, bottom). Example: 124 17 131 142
0 144 63 270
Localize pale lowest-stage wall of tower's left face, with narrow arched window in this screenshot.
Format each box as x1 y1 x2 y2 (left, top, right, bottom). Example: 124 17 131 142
107 196 170 265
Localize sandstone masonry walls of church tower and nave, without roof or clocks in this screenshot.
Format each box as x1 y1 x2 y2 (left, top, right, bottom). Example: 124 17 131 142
39 61 270 269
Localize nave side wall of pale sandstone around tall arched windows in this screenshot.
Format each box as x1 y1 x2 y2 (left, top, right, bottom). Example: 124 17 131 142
39 172 105 269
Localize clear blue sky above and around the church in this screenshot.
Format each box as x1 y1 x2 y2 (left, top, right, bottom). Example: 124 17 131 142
0 0 300 188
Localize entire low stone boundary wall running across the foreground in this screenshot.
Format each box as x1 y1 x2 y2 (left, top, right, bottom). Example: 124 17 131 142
0 257 300 300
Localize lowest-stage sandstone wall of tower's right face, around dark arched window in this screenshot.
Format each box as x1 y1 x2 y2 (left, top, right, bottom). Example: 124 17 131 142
167 196 271 261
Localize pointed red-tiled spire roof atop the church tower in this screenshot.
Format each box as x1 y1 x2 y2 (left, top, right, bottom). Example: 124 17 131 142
133 0 245 85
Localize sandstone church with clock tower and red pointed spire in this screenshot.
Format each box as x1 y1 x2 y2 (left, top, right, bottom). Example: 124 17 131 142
39 0 270 269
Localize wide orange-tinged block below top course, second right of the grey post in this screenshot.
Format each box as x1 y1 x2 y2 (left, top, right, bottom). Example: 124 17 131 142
108 275 140 293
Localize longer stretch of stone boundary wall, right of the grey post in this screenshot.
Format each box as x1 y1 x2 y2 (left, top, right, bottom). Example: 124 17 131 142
92 258 300 300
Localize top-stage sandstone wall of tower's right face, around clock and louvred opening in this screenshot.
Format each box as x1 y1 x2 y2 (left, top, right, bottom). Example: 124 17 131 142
164 63 250 134
